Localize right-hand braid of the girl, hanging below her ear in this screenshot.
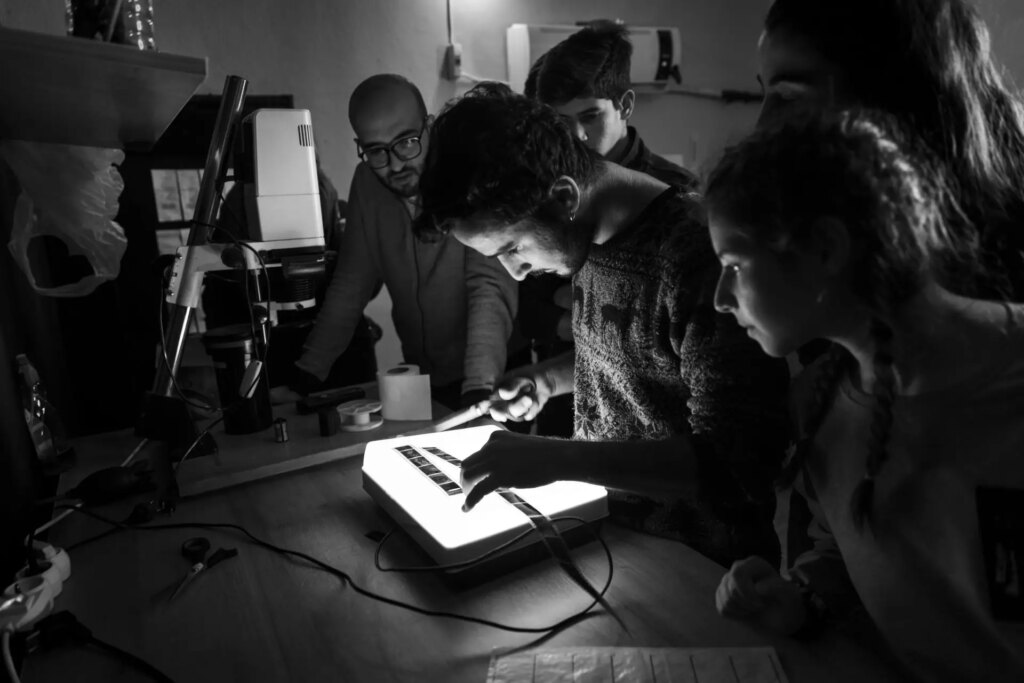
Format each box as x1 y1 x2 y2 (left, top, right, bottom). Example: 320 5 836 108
851 318 896 530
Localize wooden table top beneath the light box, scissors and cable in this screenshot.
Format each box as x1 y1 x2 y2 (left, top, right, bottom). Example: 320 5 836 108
23 413 898 683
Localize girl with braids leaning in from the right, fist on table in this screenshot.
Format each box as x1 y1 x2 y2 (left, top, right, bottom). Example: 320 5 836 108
706 112 1024 681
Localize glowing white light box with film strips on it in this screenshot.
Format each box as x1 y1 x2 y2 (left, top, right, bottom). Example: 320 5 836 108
362 426 608 564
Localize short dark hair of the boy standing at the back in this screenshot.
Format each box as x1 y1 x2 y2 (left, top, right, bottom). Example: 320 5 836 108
527 19 633 108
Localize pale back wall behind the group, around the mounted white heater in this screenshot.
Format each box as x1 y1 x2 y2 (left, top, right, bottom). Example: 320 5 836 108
8 0 1024 184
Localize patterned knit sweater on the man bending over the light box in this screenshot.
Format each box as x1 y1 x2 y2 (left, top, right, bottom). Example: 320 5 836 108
572 188 788 564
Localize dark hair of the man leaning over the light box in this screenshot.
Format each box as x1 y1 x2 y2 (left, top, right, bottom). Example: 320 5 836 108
416 83 596 238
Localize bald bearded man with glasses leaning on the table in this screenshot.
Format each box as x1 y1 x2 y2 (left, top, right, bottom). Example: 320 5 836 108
293 74 517 408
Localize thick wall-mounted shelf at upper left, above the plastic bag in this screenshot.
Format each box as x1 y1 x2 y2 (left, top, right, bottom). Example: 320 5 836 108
0 28 207 150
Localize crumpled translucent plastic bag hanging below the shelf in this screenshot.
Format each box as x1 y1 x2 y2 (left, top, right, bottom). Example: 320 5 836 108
0 140 128 297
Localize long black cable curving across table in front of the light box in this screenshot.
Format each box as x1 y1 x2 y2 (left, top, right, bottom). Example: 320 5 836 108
60 506 612 633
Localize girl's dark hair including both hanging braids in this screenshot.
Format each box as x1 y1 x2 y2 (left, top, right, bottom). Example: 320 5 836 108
705 111 965 525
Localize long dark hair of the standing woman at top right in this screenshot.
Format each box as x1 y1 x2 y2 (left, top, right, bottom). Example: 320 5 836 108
765 0 1024 301
